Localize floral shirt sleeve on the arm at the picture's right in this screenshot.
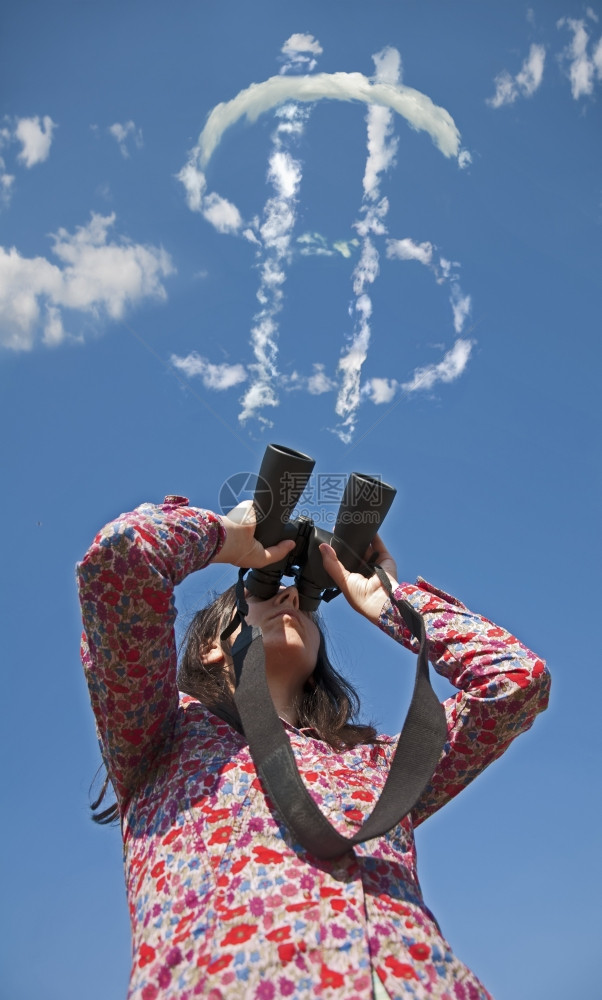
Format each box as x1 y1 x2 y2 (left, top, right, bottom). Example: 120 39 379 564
379 578 550 826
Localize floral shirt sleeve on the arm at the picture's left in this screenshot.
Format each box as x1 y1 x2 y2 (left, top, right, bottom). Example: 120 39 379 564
77 497 225 807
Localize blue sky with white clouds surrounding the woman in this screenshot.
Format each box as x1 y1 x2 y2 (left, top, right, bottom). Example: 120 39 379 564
0 0 602 1000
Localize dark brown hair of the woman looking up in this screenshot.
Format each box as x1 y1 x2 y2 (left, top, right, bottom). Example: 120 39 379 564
90 586 378 825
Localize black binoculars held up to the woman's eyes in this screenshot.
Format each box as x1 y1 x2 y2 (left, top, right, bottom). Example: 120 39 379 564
239 444 397 612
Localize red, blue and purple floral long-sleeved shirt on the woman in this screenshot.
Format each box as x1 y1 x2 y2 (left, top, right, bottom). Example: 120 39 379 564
78 497 549 1000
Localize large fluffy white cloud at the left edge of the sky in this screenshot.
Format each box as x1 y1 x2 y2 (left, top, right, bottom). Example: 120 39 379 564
0 213 174 350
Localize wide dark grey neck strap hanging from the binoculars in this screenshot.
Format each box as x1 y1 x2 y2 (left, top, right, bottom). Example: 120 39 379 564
230 566 447 859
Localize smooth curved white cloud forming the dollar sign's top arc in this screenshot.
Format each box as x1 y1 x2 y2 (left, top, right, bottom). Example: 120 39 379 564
192 73 460 169
